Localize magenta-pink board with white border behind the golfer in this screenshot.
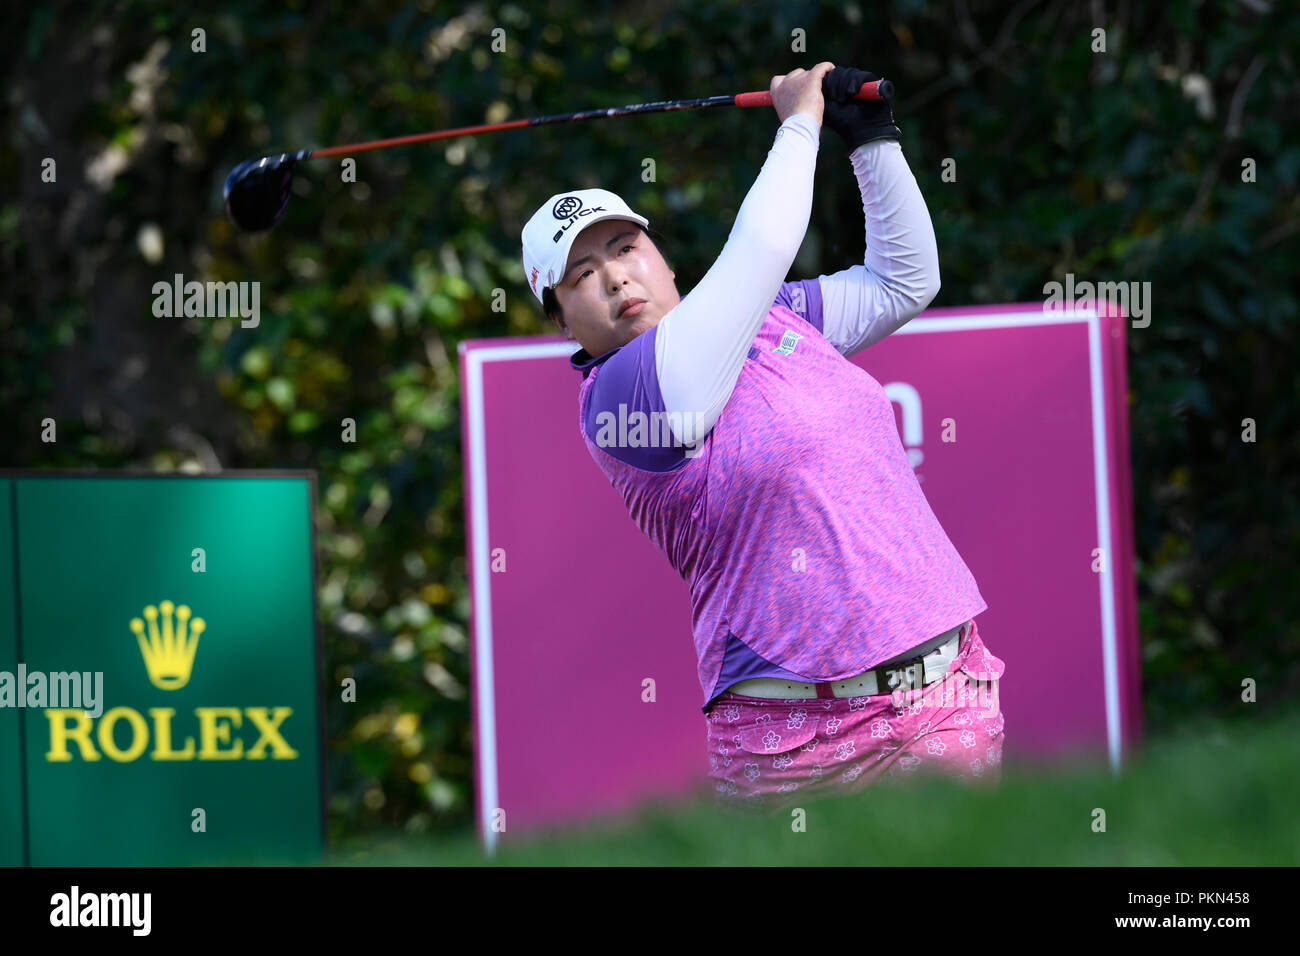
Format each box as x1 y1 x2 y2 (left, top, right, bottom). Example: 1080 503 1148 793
460 303 1141 851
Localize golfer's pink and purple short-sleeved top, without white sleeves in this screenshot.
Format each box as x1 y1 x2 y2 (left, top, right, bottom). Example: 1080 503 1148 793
571 280 988 710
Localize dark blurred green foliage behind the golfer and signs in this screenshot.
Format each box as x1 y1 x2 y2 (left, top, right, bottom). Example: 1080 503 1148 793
0 0 1300 836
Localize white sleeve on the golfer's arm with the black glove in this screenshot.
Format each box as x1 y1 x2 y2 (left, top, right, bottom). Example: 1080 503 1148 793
818 139 939 355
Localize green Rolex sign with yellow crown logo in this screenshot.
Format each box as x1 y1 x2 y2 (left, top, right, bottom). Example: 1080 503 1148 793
0 472 324 866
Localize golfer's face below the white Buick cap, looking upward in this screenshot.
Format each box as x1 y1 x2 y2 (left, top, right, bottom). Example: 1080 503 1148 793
555 219 681 356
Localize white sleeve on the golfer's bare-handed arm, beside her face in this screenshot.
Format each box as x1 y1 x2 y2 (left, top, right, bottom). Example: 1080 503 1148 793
655 70 824 445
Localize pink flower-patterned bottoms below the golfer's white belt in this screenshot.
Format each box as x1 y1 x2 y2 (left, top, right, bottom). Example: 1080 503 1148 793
707 620 1006 809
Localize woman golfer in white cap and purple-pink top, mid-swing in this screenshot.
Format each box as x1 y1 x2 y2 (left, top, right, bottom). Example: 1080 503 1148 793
523 62 1004 806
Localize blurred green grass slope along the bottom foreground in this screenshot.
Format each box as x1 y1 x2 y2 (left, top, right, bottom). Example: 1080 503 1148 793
319 711 1300 866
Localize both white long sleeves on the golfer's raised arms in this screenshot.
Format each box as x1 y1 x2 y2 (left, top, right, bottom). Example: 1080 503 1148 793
655 121 939 445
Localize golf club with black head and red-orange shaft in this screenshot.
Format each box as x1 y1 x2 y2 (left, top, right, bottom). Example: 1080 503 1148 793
222 79 893 233
